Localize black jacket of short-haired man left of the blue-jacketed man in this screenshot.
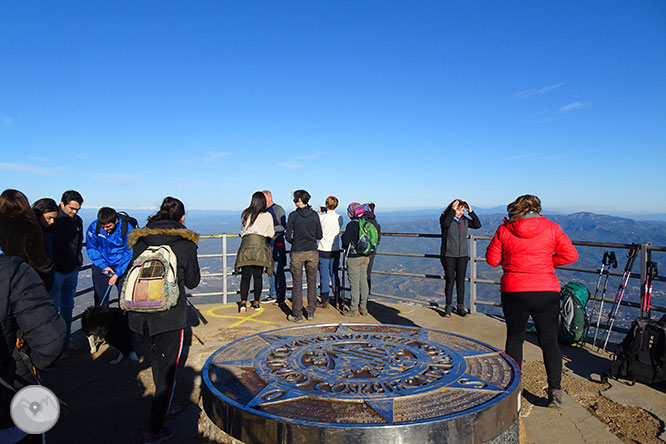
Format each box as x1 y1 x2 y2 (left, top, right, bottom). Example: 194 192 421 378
52 207 83 274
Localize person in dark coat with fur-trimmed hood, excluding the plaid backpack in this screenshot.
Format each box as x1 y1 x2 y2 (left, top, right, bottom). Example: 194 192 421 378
128 197 201 443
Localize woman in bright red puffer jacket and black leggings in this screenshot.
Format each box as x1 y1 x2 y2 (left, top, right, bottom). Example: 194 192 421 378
486 194 578 407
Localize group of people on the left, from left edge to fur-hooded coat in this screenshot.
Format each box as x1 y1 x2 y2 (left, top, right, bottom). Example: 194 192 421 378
0 189 201 443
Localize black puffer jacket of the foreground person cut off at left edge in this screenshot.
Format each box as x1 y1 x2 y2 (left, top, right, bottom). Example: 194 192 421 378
0 255 67 429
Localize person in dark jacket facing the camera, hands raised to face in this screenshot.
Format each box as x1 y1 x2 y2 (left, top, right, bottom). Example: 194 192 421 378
439 199 481 316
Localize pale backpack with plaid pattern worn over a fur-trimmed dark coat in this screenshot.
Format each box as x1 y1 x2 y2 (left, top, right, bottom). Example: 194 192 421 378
120 245 180 312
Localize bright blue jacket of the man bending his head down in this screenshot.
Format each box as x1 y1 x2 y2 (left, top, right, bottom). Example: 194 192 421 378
86 218 134 276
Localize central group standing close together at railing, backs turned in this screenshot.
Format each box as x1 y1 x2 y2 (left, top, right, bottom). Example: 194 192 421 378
235 190 380 323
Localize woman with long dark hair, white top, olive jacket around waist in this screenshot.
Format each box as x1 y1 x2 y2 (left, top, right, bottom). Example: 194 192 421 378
235 191 275 312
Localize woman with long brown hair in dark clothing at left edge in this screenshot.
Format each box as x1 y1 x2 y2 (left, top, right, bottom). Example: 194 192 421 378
0 189 55 285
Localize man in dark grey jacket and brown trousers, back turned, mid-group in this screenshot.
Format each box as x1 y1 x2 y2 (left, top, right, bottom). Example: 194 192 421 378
285 190 322 322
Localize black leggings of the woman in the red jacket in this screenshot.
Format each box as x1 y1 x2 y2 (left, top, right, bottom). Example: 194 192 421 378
502 291 562 389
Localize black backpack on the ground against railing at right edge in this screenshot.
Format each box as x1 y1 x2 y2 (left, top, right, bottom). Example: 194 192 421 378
608 315 666 384
